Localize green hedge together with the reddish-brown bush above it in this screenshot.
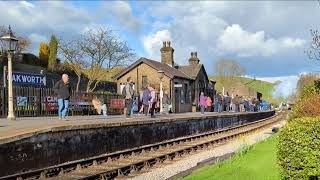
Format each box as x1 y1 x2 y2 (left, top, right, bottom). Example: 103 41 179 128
278 83 320 180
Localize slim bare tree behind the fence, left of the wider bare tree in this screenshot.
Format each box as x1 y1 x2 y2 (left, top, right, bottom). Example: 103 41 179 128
58 40 88 92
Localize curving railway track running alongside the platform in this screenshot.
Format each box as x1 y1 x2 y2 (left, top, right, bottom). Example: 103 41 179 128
0 113 285 180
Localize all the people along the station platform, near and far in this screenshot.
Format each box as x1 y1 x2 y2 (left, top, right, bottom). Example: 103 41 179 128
54 74 270 119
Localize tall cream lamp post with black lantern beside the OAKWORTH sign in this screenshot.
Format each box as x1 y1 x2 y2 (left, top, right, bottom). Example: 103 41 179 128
0 26 19 120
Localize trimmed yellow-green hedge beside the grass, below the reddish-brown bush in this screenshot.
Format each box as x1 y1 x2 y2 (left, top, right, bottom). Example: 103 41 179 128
277 116 320 179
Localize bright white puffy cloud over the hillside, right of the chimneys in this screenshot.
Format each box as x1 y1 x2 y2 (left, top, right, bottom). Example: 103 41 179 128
217 24 305 57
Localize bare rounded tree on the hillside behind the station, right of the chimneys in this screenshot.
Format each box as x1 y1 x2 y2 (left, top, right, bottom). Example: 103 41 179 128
214 59 245 88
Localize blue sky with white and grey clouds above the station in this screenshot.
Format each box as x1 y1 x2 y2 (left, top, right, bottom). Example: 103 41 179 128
0 1 320 97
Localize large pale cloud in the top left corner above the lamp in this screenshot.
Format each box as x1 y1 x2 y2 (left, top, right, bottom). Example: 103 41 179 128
0 1 93 54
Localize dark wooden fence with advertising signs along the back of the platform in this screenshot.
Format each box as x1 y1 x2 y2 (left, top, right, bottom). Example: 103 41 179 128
0 86 123 117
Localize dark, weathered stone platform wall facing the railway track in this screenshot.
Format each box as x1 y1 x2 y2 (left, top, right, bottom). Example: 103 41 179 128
0 111 274 176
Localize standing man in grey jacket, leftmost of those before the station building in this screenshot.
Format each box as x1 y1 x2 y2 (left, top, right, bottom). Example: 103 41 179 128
122 77 134 118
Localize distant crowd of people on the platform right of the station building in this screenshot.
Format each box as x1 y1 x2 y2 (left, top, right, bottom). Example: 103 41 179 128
198 92 271 114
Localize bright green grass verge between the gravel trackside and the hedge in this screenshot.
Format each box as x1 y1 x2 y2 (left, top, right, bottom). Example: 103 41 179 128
183 135 280 180
